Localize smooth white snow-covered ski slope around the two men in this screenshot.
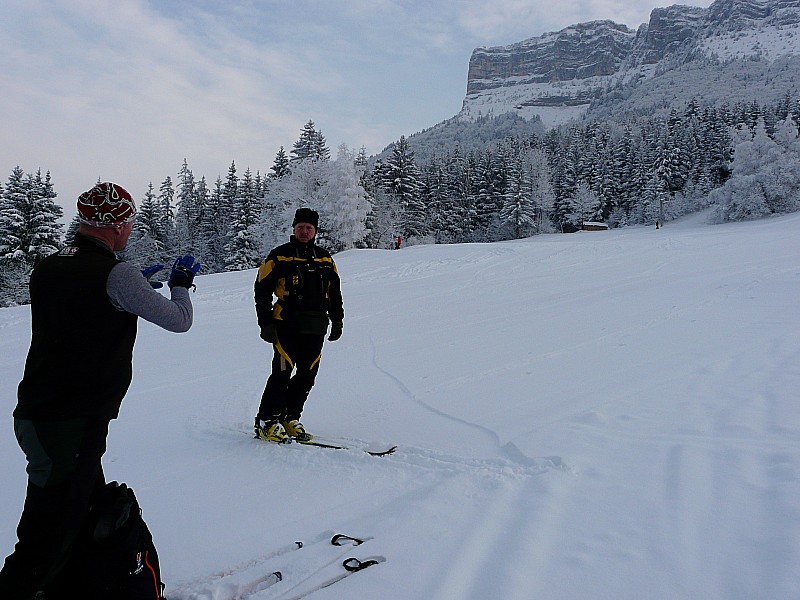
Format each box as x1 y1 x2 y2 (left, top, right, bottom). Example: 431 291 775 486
0 215 800 600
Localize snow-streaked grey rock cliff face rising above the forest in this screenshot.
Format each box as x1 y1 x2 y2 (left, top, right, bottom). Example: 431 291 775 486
459 0 800 126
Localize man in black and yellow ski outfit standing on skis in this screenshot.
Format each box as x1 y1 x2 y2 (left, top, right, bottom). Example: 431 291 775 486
255 208 344 442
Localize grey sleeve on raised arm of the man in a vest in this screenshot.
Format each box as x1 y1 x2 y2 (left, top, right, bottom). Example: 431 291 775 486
106 262 193 333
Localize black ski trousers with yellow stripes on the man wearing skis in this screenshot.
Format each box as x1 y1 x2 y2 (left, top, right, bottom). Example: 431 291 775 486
258 325 325 421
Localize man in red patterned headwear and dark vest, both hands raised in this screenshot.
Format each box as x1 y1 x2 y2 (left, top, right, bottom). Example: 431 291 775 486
0 183 200 600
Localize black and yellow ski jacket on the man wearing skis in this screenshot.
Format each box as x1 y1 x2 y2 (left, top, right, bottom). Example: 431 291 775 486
255 236 344 335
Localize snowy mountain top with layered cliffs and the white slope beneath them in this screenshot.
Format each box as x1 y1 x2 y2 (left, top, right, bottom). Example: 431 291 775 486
458 0 800 126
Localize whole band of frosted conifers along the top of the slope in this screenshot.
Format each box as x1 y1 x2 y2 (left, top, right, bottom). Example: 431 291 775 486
0 94 800 305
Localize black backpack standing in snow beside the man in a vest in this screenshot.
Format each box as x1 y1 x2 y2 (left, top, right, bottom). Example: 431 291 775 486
44 481 164 600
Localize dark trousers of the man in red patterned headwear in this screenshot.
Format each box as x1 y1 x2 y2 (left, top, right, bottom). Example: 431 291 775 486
0 419 108 600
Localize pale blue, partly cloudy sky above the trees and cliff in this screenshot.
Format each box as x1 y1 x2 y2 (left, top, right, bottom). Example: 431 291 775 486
0 0 711 212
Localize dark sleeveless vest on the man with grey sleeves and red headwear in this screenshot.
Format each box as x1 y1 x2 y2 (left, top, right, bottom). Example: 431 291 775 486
14 235 137 420
